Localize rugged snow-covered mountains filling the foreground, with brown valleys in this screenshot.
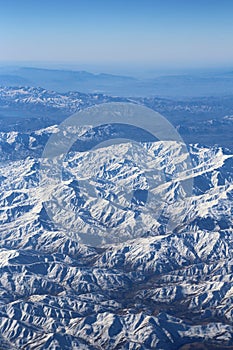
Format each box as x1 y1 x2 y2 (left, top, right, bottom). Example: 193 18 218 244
0 122 233 350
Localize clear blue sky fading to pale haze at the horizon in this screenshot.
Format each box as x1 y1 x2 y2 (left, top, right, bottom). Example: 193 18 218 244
0 0 233 72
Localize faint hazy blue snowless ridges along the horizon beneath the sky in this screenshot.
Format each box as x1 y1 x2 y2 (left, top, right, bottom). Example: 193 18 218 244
0 67 233 98
